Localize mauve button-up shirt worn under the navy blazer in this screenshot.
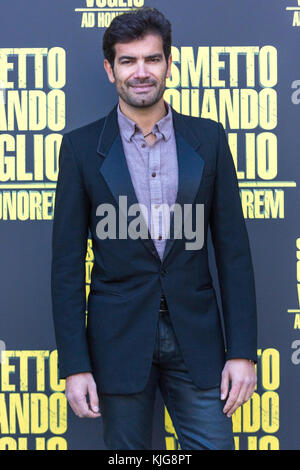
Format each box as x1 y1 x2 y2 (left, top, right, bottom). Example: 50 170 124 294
117 101 178 259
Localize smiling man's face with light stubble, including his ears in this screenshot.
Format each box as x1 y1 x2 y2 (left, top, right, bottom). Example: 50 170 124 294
104 33 172 108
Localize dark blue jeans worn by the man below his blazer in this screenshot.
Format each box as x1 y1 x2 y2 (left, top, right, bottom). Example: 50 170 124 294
99 296 234 450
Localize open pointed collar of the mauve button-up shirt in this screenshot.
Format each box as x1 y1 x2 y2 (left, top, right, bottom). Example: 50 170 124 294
117 100 173 142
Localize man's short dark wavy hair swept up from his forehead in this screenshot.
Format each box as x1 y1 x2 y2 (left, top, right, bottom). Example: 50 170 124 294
102 7 172 68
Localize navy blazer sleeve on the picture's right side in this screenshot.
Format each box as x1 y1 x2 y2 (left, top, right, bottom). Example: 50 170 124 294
210 123 257 362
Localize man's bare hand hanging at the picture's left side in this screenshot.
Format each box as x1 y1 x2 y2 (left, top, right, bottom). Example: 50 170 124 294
65 372 101 418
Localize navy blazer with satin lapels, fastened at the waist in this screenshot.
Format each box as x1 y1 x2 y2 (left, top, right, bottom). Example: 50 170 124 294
51 105 257 394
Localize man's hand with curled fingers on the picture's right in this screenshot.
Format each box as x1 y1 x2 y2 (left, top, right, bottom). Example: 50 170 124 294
221 359 257 418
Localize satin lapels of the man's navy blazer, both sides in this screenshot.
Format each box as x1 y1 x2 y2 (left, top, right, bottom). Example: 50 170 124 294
97 105 204 263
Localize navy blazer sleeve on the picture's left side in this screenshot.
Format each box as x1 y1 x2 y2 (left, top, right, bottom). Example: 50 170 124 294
51 134 91 378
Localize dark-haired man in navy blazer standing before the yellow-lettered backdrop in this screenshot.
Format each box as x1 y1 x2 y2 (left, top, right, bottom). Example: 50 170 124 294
52 7 257 449
